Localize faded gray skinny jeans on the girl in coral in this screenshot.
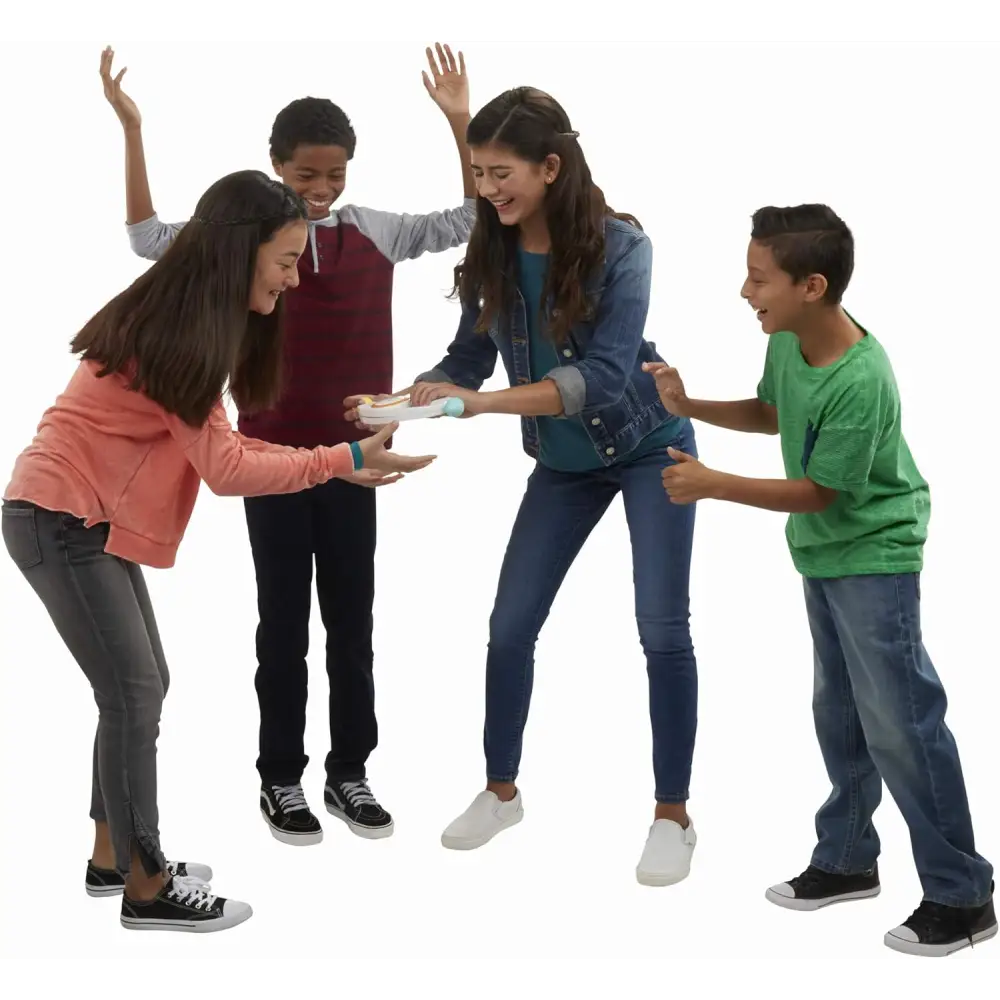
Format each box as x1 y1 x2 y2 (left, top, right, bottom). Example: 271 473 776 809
3 501 169 875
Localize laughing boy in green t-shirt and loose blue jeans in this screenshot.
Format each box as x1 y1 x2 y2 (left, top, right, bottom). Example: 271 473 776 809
647 205 997 956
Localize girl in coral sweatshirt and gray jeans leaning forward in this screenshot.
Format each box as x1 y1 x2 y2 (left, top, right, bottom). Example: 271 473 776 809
2 171 433 931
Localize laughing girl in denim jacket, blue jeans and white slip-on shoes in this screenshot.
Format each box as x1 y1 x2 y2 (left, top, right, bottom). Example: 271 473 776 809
345 87 697 885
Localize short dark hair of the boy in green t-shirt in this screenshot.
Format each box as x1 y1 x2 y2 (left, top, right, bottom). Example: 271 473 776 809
751 205 854 305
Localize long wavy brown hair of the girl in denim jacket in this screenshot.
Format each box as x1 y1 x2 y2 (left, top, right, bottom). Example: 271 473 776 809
452 87 642 343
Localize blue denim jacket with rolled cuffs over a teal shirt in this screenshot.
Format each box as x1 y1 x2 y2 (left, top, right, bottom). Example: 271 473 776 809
415 216 674 466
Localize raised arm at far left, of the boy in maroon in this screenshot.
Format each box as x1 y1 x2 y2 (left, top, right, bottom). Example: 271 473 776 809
101 46 183 260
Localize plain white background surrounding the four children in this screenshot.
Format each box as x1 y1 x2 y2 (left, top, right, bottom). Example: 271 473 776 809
0 39 1000 960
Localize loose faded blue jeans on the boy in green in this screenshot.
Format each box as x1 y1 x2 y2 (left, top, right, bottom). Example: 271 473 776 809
805 574 993 906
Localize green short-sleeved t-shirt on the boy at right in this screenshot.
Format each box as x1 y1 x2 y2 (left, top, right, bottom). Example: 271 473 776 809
757 331 931 577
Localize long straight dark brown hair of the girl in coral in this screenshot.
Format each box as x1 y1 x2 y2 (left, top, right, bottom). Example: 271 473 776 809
70 170 307 427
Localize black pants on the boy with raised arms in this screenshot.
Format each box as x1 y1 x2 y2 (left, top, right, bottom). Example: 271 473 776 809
244 479 378 785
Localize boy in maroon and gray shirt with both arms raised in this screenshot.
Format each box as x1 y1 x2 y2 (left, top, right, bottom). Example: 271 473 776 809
101 45 476 845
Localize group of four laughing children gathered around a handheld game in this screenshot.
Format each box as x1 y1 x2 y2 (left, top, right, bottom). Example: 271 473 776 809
3 46 997 956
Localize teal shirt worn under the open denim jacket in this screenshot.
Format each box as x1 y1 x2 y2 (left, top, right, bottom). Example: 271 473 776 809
518 248 677 472
